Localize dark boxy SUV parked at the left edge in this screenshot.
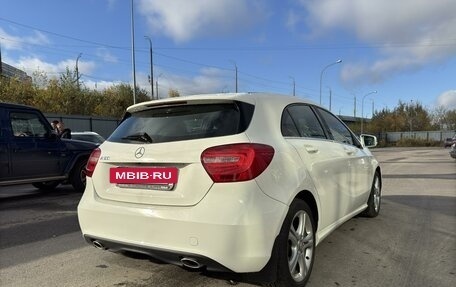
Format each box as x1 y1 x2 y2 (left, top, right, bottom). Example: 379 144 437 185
0 103 97 192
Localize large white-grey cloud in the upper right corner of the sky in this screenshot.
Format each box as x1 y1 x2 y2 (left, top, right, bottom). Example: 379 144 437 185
296 0 456 83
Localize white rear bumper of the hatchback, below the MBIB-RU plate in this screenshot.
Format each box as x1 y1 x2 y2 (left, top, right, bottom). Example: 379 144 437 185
78 178 288 273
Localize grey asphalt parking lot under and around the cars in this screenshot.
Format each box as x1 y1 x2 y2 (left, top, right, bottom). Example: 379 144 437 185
0 148 456 287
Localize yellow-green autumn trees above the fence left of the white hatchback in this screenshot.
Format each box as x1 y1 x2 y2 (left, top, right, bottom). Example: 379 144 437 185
0 68 150 118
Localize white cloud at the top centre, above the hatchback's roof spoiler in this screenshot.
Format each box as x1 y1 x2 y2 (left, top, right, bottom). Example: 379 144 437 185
139 0 267 42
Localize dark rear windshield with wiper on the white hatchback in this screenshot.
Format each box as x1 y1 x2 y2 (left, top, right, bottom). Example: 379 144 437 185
108 102 254 143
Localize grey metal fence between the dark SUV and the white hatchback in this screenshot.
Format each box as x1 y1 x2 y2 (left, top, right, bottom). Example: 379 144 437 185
45 114 120 138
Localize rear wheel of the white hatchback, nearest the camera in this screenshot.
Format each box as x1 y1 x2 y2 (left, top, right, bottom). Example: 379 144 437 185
270 199 316 287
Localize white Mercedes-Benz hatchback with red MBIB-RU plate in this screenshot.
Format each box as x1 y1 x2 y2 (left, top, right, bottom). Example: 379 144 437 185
78 93 382 286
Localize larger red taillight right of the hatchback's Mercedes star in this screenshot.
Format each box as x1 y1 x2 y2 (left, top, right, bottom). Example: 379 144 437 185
201 143 274 182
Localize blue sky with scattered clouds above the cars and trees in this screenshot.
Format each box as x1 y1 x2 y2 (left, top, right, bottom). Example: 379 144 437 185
0 0 456 116
